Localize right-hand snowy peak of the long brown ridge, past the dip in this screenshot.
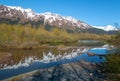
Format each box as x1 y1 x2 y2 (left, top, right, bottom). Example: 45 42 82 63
40 12 90 29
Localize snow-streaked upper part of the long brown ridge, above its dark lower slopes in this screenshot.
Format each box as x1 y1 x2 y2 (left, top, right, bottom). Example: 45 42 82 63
0 5 90 29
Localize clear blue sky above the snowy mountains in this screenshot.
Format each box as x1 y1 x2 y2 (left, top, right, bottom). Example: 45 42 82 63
0 0 120 26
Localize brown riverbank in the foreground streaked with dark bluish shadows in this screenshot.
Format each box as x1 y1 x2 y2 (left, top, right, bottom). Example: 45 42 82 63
3 60 106 81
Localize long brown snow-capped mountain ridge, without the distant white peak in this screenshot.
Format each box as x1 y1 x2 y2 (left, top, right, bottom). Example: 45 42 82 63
0 5 91 30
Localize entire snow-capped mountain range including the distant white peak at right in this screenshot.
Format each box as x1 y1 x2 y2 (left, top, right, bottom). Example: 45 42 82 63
0 5 116 34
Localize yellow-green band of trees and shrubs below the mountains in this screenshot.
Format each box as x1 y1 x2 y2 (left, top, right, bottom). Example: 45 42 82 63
0 23 111 48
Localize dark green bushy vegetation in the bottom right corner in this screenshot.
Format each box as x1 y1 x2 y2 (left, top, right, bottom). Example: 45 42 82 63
104 52 120 81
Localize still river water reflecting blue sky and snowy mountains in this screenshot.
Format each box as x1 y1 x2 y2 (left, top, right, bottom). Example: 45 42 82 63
0 40 113 80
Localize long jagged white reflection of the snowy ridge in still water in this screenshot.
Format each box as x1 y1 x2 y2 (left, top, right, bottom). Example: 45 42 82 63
1 48 89 69
